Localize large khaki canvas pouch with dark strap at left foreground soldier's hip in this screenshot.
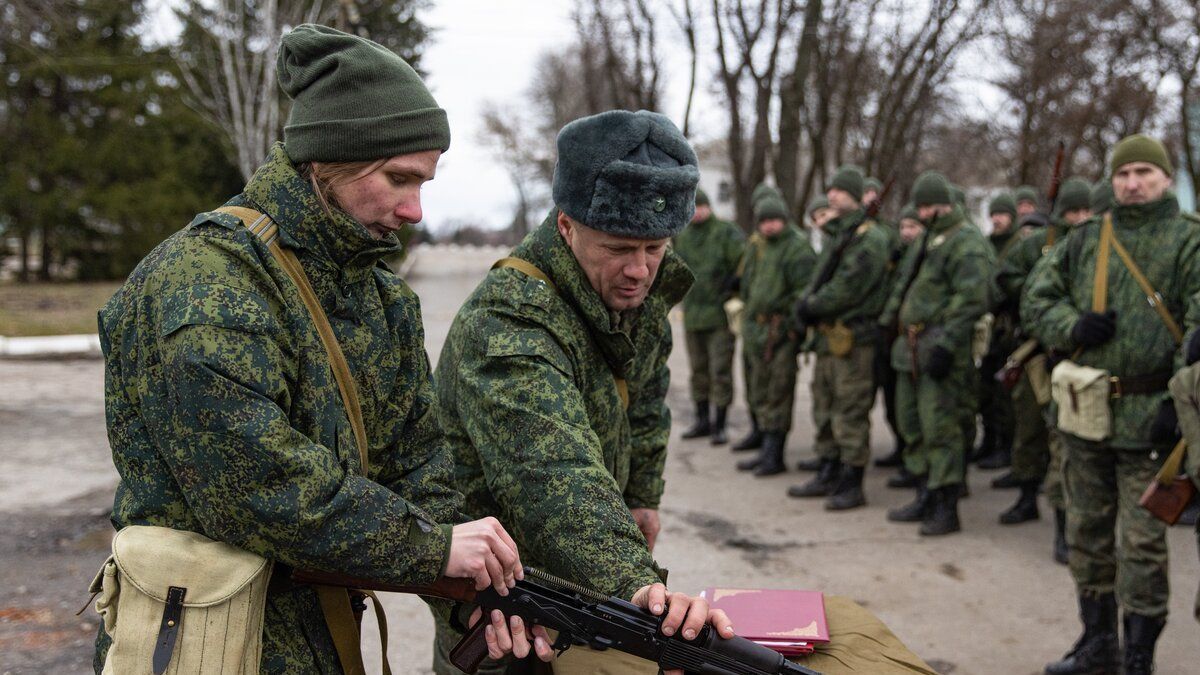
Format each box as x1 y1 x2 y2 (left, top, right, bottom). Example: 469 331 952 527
91 525 271 675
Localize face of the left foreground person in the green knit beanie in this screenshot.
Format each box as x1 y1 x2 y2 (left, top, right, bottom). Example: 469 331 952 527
332 150 442 239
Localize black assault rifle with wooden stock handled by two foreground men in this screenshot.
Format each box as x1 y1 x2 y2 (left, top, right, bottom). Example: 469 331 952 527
292 567 820 675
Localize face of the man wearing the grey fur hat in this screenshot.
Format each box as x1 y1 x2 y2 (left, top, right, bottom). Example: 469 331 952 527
558 211 670 312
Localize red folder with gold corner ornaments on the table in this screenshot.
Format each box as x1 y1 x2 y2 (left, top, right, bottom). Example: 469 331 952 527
701 589 829 656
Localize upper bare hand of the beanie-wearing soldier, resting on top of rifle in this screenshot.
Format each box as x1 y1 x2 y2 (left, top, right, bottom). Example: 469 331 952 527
445 516 524 596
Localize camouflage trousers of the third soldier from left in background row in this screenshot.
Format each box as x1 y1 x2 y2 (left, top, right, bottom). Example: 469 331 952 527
812 344 875 466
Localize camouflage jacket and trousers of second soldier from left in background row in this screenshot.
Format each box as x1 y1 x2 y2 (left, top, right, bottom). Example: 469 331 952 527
742 226 816 432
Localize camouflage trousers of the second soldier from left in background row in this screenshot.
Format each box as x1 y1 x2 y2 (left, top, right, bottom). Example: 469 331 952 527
742 319 799 434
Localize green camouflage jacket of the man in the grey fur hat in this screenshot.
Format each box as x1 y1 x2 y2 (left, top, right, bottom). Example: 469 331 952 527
434 210 691 598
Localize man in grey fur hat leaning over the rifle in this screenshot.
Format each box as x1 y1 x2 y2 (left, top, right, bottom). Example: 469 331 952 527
434 110 732 674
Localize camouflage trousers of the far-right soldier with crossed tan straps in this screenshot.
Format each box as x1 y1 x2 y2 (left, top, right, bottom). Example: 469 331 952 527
1061 434 1169 617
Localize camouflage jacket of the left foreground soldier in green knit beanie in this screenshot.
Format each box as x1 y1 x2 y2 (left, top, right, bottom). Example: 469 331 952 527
100 145 462 673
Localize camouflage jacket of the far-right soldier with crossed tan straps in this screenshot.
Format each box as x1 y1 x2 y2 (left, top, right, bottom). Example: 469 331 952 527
1021 196 1200 448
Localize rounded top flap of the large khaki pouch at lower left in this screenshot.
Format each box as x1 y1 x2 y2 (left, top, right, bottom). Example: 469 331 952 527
113 525 269 607
